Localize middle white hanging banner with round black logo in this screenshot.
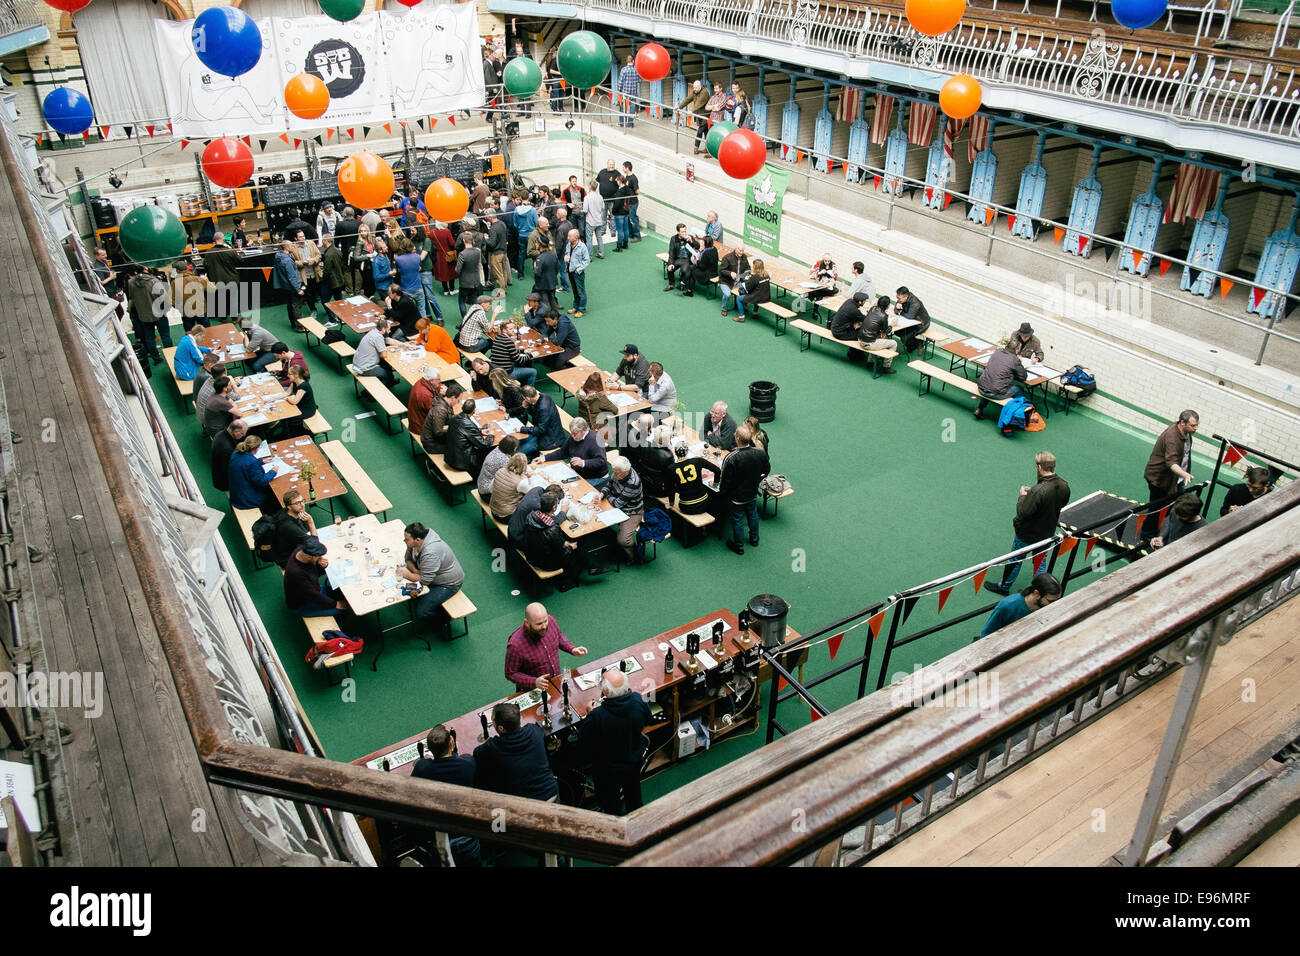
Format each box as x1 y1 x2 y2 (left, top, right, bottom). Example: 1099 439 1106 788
274 13 393 130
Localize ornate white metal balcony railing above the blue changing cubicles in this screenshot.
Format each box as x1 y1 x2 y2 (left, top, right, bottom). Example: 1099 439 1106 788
584 0 1300 139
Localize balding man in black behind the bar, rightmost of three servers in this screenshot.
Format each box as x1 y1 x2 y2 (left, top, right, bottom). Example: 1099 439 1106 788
577 669 650 816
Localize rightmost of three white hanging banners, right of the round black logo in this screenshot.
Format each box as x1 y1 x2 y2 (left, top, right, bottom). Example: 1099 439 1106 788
380 4 484 120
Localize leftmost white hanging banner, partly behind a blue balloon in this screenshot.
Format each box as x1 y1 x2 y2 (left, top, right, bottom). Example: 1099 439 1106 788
153 17 285 139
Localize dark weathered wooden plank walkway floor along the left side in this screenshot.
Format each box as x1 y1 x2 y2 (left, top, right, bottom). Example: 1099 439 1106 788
0 172 276 866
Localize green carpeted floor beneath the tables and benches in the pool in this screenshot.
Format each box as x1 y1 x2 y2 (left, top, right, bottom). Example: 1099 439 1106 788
153 235 1209 796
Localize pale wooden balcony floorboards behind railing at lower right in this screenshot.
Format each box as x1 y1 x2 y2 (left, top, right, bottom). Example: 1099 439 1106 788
871 600 1300 866
